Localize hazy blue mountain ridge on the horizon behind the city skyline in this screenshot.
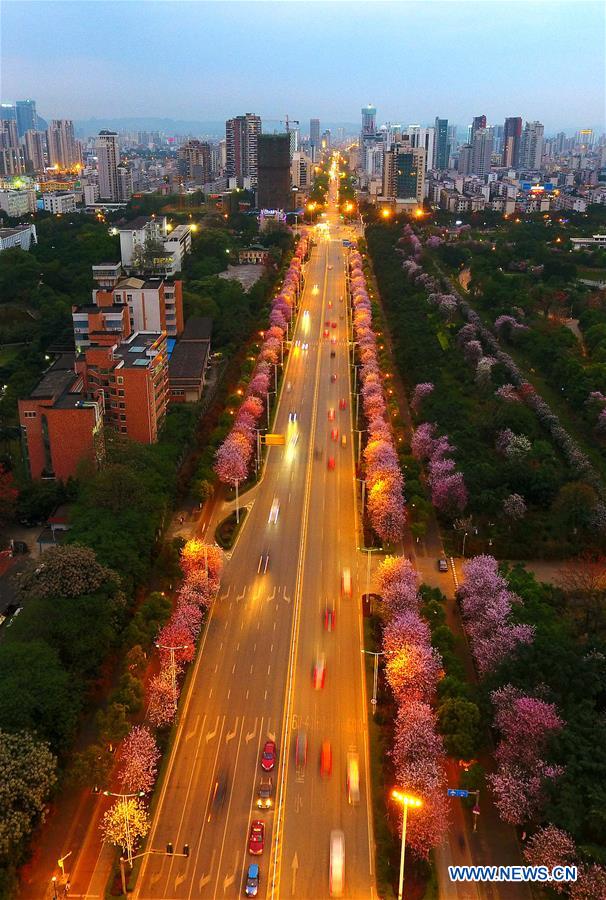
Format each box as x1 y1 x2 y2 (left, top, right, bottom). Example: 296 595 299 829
74 116 360 138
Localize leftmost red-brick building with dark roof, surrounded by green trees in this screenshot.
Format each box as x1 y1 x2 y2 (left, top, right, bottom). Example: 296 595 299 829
19 353 103 481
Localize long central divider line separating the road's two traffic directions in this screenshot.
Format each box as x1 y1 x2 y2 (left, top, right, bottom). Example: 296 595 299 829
270 237 328 900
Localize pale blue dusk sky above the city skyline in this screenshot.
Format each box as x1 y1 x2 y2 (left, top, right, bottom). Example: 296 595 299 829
1 0 605 131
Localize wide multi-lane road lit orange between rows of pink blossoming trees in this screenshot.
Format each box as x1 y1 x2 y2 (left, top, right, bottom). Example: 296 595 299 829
134 163 376 900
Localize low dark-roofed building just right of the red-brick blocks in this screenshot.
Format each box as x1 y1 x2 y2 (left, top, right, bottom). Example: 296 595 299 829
168 316 212 403
